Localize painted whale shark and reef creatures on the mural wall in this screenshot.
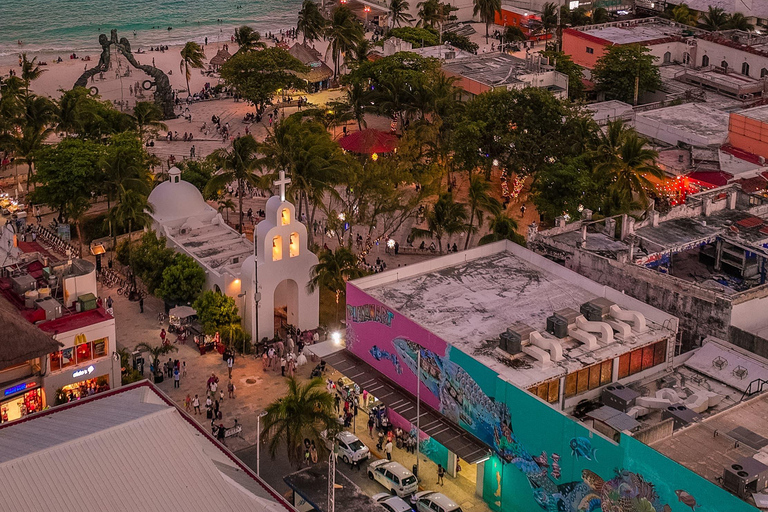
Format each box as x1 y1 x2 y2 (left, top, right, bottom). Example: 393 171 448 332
388 337 676 512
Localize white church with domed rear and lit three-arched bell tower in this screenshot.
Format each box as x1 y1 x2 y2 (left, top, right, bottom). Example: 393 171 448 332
148 167 320 342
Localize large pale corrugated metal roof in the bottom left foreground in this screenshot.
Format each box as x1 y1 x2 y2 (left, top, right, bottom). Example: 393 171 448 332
0 381 295 512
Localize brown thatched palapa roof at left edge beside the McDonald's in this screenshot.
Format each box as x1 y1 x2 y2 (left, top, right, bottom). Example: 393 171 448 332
0 295 62 370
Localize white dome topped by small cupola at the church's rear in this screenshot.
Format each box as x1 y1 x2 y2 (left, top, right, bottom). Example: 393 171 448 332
147 167 216 223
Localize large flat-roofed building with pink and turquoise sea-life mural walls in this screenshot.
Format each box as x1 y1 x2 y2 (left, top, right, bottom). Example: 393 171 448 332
311 241 752 512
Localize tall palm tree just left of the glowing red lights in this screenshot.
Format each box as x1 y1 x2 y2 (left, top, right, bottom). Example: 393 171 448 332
595 131 664 206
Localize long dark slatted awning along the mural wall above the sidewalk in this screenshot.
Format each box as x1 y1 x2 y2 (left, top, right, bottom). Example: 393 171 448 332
320 347 491 464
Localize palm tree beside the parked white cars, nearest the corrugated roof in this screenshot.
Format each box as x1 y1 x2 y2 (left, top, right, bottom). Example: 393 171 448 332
261 377 340 467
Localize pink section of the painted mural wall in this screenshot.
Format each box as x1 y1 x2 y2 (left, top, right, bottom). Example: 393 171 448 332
347 283 448 409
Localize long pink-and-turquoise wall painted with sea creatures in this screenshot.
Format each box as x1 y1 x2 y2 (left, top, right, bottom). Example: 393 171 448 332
347 285 757 512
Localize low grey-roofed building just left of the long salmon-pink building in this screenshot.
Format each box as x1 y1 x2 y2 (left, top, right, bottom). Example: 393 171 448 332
443 53 568 99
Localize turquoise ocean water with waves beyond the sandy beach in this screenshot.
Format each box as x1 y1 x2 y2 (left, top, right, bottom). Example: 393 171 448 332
0 0 302 56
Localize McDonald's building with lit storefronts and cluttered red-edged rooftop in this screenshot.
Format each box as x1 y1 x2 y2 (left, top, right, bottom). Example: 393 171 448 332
0 227 121 420
